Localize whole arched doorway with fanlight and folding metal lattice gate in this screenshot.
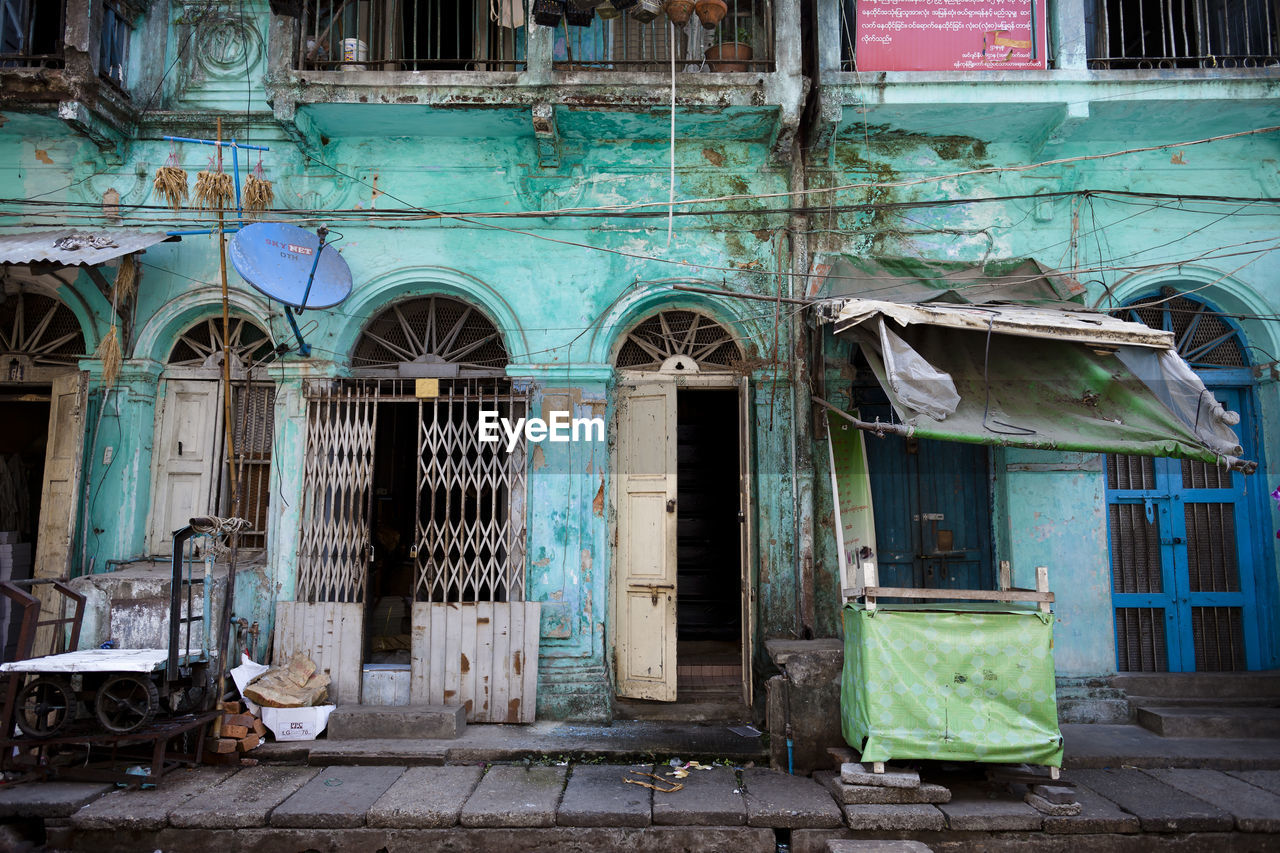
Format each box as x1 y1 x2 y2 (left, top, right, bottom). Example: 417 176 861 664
284 295 539 722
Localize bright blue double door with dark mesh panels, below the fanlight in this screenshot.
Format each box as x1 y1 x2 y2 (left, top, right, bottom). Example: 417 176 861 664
1107 387 1265 672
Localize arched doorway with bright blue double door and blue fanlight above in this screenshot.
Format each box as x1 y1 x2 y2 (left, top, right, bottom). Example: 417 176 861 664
1106 287 1266 672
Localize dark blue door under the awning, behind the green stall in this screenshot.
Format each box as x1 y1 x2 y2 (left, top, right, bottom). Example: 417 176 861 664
867 425 995 589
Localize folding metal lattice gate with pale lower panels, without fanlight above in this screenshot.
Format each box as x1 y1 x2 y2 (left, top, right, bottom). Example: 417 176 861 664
276 378 540 722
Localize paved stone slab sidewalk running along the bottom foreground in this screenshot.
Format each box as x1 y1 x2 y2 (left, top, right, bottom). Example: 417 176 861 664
0 763 1280 853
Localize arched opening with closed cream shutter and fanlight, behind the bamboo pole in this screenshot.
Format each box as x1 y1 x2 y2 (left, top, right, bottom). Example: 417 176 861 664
147 315 275 553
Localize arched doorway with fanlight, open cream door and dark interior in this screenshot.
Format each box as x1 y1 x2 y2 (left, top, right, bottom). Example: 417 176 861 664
613 309 754 704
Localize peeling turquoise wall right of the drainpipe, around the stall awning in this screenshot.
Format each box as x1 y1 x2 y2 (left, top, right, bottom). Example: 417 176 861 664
809 124 1280 675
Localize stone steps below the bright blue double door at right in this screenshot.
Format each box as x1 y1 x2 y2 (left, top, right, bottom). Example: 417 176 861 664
1112 671 1280 738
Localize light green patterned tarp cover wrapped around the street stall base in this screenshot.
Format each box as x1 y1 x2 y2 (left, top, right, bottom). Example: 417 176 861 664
840 596 1062 767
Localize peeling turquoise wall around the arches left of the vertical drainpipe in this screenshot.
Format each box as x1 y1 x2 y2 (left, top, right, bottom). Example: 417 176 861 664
0 3 797 719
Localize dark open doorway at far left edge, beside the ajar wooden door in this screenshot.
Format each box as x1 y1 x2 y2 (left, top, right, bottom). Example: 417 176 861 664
0 387 50 661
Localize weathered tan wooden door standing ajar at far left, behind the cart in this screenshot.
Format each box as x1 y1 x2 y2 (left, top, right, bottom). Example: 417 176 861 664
35 371 88 653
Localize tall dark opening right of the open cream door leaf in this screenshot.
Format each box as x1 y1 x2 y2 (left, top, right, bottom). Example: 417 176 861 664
676 388 742 699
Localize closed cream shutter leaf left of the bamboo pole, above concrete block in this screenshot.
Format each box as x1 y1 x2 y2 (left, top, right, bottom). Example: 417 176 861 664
147 379 223 555
